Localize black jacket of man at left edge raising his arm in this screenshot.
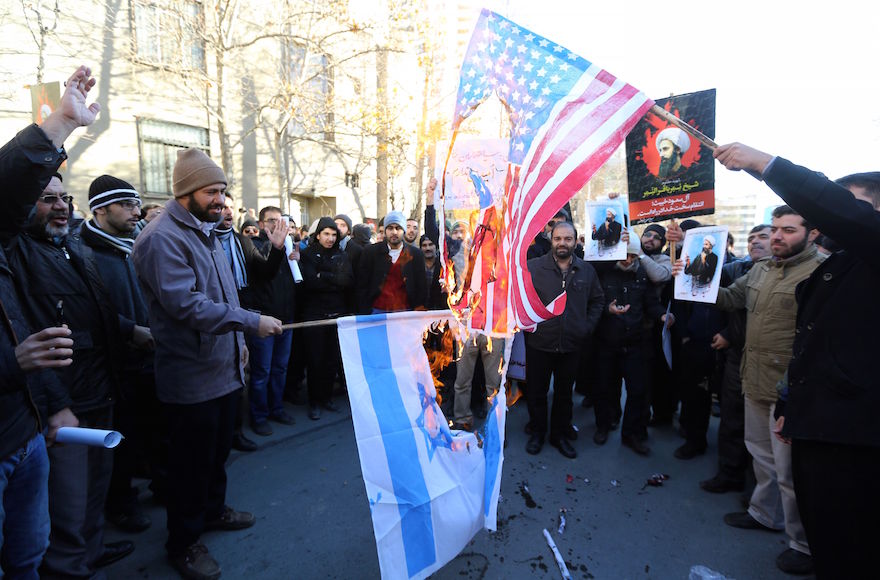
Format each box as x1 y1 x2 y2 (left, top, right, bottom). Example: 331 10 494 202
0 125 70 460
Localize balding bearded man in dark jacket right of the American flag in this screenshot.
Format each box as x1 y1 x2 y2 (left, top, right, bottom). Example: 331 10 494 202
524 221 605 458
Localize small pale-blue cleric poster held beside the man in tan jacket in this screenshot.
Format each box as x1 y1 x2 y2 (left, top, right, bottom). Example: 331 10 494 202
675 226 727 304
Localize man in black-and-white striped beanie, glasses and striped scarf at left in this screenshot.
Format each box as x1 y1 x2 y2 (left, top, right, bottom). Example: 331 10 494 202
81 175 161 532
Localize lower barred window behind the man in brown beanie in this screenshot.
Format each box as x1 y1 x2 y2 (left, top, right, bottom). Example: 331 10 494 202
137 119 211 199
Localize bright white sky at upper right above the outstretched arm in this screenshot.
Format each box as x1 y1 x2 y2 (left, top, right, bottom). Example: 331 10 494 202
482 0 880 217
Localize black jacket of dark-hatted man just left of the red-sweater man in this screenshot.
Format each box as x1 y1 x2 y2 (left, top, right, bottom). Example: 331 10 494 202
300 241 354 320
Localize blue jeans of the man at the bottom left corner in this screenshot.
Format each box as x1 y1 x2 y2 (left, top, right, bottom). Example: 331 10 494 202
0 434 49 579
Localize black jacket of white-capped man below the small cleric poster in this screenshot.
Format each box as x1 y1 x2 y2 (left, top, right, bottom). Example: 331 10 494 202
593 262 666 348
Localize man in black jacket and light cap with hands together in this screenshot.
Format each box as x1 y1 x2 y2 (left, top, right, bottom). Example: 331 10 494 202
593 239 671 455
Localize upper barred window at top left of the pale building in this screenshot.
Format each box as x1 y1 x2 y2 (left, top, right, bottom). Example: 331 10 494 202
132 0 205 71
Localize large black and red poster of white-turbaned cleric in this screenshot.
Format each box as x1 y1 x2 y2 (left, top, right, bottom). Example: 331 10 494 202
626 89 715 225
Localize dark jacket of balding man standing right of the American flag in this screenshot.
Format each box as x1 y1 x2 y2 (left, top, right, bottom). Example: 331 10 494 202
526 254 605 352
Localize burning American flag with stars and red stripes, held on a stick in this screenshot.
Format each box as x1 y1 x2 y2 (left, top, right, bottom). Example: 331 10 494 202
440 9 653 330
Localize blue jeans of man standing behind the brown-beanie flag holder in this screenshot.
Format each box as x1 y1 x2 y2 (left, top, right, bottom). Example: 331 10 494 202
247 330 293 423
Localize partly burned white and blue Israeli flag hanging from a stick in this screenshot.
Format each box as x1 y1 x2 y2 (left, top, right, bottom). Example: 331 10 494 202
337 310 507 578
